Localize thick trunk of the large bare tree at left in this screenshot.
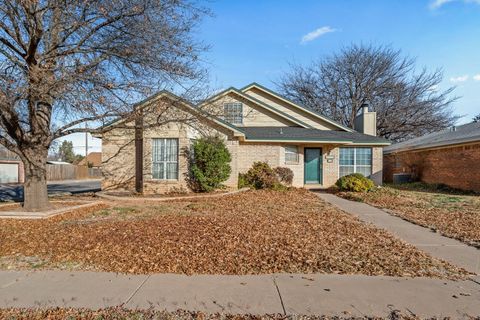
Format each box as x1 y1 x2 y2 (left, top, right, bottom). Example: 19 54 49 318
23 149 50 211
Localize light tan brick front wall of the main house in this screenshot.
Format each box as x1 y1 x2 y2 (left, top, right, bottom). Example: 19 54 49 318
102 97 383 193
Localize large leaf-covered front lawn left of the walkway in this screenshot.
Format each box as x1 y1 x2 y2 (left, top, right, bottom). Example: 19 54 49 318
0 190 464 277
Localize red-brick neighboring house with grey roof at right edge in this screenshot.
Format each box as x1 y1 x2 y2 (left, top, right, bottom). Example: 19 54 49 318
383 122 480 192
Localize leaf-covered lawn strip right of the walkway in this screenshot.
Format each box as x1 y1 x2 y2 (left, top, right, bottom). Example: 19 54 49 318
340 184 480 248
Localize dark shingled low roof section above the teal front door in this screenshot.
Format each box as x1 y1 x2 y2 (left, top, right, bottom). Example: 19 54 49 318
242 127 390 146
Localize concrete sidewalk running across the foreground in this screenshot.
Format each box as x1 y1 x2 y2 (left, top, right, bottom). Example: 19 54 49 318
0 271 480 318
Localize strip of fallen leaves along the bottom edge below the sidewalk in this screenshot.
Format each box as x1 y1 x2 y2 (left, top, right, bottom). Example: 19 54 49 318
0 307 437 320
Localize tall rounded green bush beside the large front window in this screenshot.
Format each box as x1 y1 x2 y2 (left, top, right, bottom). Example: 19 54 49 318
190 137 232 192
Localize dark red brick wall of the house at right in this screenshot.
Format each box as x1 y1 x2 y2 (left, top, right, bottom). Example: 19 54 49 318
384 143 480 191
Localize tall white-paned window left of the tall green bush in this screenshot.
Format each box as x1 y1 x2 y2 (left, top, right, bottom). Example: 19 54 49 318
152 138 178 180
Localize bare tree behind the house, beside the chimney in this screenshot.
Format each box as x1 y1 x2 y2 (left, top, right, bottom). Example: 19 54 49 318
277 45 457 141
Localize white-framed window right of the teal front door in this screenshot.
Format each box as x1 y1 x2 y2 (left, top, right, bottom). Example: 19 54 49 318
339 148 372 177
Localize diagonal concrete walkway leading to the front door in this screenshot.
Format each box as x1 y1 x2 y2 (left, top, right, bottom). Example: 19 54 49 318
316 192 480 274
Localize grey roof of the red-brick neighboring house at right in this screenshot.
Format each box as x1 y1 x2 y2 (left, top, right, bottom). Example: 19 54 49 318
384 122 480 154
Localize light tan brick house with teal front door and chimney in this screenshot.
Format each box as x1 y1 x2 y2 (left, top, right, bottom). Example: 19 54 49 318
100 83 390 193
